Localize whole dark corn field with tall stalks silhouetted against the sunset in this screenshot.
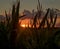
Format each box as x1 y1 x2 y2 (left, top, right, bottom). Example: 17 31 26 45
0 0 60 49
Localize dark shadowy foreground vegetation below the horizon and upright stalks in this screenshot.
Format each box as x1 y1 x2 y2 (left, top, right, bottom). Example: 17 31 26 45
0 28 60 49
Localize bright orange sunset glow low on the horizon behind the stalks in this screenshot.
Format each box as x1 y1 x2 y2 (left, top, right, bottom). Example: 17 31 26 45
19 17 60 28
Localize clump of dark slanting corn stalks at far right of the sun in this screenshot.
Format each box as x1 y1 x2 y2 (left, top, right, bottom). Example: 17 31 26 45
39 8 57 28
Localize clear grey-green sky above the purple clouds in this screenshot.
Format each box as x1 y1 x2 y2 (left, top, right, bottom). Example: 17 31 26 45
0 0 60 15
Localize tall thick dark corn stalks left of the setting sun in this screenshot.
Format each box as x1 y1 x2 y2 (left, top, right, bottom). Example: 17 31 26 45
5 1 25 47
